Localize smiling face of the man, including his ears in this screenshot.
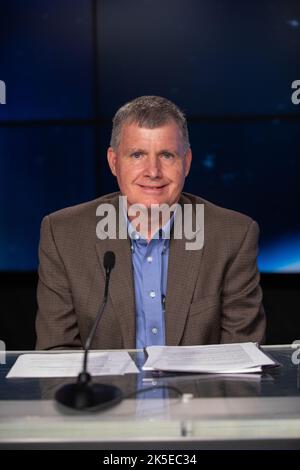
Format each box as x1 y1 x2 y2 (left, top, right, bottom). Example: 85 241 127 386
107 122 192 208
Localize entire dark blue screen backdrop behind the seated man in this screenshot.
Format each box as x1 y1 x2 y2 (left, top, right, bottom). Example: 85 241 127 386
0 0 300 272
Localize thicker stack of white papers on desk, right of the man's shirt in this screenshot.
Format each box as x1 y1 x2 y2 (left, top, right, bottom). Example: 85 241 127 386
143 343 277 374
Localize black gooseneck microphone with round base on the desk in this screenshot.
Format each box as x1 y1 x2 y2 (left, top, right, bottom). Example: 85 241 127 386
55 251 123 411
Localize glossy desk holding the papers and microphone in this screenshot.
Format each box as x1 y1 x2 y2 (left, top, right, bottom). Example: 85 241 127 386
0 345 300 450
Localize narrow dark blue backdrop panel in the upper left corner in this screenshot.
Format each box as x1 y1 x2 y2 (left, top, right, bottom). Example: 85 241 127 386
0 0 93 121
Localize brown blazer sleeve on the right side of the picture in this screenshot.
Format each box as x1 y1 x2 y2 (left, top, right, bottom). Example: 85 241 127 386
220 221 266 343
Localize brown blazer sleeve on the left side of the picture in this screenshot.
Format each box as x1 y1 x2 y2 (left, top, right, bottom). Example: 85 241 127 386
36 216 81 349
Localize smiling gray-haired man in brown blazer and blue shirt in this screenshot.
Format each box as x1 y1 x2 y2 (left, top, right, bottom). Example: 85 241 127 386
36 96 265 349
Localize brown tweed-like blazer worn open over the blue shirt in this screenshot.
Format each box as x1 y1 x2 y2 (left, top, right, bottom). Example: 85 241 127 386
36 193 265 349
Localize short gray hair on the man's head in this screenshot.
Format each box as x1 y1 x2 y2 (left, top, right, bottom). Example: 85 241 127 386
110 96 190 152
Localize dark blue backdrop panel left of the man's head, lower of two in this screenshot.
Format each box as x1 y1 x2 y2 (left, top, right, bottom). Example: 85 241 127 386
0 126 96 270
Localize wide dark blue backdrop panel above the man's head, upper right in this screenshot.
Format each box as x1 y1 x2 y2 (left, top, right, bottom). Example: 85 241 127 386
98 0 300 116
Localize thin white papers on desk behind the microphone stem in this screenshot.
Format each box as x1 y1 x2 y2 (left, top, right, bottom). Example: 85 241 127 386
6 351 139 379
